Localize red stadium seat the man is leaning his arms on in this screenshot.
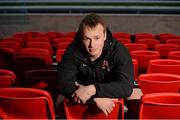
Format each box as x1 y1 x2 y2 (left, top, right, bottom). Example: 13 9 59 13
64 99 124 119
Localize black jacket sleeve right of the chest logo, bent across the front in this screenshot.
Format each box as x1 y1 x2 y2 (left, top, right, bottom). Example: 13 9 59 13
95 47 134 98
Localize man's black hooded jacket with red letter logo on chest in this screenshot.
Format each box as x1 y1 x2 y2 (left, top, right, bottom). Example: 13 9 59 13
57 29 134 98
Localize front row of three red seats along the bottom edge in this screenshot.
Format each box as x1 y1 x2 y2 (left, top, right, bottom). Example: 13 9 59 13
0 88 180 119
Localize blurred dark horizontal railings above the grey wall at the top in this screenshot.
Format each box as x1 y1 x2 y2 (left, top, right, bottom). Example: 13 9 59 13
0 0 180 14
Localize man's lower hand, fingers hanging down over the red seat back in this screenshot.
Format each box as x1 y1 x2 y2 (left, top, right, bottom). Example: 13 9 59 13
94 98 115 116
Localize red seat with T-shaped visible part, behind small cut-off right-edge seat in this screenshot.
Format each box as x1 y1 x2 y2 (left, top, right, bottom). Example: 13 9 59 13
155 44 180 58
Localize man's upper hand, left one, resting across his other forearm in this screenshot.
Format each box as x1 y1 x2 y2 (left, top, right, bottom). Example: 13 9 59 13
72 82 96 104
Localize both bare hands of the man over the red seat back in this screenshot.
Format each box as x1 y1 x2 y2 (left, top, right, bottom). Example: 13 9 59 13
72 82 115 116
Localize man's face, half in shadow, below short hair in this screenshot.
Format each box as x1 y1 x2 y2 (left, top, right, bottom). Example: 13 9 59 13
82 24 106 60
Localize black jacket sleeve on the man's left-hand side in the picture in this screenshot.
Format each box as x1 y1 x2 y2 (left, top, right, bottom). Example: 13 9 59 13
57 49 77 96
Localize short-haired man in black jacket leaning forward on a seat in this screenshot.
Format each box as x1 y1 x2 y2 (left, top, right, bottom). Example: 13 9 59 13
58 14 134 115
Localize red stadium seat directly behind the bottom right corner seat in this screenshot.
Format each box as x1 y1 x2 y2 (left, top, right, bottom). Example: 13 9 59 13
138 73 180 94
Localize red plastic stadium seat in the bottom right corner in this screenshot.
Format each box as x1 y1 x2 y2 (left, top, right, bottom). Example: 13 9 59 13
139 93 180 120
